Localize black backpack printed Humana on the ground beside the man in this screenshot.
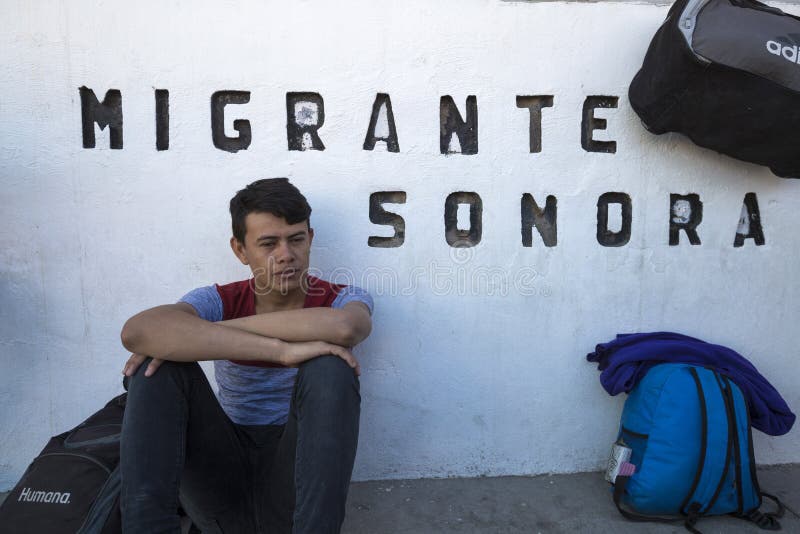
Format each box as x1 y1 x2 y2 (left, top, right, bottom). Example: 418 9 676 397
0 393 127 534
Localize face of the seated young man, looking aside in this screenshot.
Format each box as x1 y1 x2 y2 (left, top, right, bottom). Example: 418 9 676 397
231 213 314 295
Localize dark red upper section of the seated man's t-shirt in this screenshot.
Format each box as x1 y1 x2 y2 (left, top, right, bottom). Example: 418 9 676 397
216 276 345 367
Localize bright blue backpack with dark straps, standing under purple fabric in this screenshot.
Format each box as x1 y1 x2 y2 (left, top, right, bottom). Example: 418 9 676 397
614 364 783 532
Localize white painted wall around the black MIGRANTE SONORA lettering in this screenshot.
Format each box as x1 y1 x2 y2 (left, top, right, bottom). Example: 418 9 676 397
0 0 800 490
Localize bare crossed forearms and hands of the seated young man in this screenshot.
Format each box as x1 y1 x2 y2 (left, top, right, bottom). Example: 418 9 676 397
121 302 372 376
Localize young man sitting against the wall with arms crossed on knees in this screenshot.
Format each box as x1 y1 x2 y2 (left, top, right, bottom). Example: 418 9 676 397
121 178 372 534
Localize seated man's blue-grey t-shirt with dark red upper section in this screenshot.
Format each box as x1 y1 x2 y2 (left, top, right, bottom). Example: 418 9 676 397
180 276 373 425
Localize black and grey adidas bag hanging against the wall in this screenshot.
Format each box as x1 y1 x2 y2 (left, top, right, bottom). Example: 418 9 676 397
628 0 800 178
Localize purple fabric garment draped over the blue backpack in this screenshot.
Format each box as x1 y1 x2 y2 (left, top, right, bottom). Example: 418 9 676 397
586 332 795 436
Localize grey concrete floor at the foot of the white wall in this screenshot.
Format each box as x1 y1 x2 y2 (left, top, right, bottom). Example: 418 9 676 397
0 464 800 534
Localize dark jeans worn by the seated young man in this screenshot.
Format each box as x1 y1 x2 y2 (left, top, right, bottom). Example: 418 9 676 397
120 356 361 534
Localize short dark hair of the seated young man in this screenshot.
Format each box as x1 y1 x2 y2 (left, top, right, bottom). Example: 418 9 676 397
231 178 311 243
